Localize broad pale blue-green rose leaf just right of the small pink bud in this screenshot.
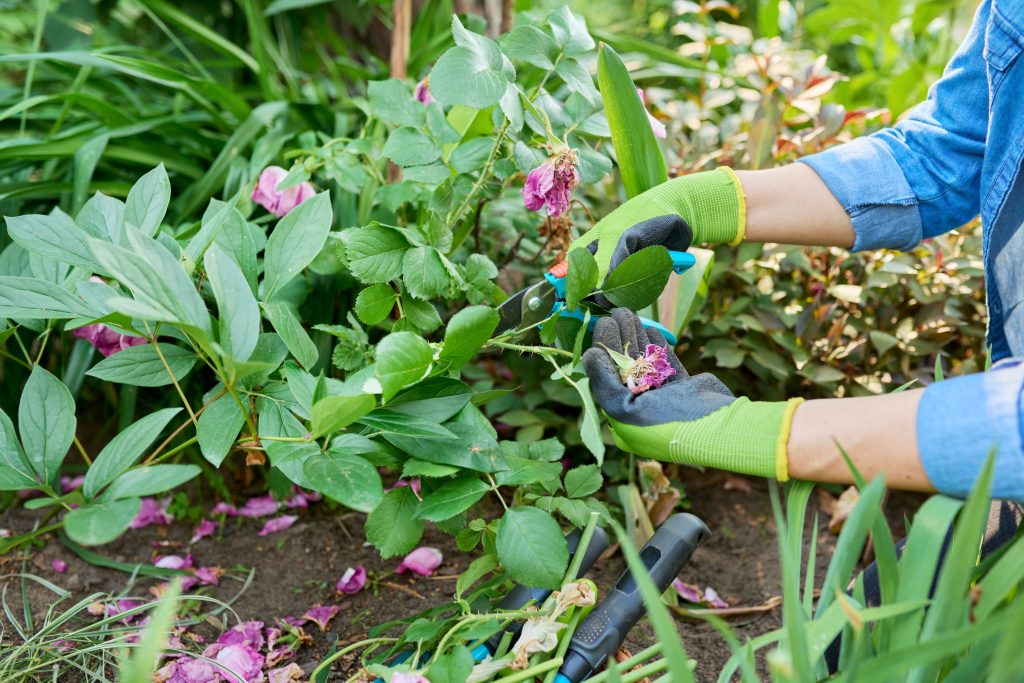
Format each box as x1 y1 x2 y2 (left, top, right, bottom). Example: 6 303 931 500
430 15 515 110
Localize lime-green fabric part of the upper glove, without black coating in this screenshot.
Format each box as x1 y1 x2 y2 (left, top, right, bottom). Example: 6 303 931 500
570 167 746 278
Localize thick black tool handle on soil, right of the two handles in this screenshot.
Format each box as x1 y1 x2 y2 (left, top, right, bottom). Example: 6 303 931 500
559 512 711 683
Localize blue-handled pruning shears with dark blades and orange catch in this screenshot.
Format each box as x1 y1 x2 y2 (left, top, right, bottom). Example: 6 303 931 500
498 251 696 345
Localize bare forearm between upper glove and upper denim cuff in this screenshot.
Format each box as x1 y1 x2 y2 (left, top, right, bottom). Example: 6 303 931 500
736 164 854 248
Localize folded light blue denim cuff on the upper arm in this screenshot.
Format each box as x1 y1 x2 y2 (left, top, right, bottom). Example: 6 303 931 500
800 136 922 251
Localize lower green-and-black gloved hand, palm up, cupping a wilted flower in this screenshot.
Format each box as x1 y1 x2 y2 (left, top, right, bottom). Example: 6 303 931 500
583 308 803 481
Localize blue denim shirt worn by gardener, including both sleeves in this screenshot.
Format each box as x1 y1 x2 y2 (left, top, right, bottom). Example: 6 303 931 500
803 0 1024 499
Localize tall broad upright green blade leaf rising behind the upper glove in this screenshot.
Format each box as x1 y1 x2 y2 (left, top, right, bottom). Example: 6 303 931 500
598 43 669 197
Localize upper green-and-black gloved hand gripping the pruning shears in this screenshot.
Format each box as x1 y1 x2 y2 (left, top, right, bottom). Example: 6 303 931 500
570 167 746 278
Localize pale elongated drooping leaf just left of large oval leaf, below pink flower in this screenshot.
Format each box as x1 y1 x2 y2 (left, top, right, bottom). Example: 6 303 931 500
203 245 260 360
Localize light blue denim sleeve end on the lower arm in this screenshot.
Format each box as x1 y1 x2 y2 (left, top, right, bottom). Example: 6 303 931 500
918 360 1024 500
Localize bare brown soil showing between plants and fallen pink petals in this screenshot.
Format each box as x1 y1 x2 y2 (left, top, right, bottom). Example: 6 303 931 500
0 470 923 682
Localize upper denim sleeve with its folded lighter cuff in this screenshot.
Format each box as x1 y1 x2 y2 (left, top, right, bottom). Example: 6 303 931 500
801 0 991 251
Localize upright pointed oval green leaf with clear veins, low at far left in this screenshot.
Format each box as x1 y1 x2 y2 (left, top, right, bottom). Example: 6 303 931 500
17 364 77 485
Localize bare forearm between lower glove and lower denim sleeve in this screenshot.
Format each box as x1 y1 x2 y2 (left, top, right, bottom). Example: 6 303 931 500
786 390 935 492
